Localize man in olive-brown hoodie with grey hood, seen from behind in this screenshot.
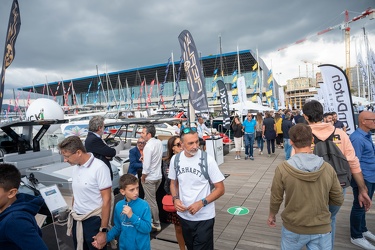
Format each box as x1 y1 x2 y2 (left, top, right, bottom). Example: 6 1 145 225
267 123 344 249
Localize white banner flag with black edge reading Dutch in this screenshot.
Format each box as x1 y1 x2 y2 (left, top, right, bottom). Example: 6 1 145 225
319 64 355 134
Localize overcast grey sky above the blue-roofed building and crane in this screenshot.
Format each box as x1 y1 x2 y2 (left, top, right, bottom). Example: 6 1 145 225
0 0 375 98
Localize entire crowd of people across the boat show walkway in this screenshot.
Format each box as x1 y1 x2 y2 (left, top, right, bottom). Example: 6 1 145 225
0 101 375 250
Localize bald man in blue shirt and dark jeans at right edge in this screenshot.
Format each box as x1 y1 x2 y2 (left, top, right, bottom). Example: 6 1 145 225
350 111 375 249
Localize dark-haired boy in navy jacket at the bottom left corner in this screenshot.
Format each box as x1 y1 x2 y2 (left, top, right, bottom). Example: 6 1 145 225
0 164 48 250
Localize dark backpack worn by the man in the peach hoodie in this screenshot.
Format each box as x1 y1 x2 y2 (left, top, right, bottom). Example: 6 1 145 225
313 129 352 188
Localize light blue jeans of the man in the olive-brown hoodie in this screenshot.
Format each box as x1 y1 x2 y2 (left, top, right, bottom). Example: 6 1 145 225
281 226 331 250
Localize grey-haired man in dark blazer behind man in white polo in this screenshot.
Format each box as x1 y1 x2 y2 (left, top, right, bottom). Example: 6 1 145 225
85 116 116 180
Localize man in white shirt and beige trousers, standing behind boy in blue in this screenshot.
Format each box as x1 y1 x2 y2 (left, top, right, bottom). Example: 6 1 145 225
141 125 163 231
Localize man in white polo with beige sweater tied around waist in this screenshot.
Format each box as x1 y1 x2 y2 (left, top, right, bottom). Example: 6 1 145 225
58 136 112 250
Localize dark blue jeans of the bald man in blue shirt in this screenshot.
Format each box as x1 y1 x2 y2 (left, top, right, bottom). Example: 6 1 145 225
350 179 375 239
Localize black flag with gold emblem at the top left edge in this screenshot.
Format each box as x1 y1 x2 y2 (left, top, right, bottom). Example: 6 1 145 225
0 0 21 110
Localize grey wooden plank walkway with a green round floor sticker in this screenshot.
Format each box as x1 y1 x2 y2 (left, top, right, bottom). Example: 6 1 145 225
151 149 375 250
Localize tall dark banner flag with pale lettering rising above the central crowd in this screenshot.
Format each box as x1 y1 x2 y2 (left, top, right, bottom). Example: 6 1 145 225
178 30 208 111
